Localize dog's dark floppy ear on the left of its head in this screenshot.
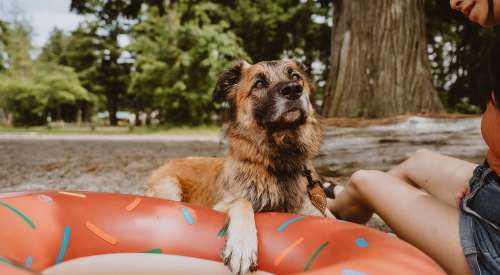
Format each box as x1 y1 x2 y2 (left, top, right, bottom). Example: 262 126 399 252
212 61 248 103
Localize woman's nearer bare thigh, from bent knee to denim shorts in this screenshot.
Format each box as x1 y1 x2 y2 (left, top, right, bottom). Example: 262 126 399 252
351 171 469 274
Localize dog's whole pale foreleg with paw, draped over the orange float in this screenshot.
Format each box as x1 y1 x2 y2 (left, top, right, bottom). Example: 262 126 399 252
214 199 258 274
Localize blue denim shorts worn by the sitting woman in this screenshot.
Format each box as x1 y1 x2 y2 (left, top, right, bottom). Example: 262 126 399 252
459 165 500 275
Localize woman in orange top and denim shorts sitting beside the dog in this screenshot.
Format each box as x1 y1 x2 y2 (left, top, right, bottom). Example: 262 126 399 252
329 0 500 274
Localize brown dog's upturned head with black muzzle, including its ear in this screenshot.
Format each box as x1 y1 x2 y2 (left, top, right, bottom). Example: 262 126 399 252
214 60 314 132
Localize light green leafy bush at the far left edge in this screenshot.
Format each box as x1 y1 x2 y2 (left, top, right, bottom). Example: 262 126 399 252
0 22 96 125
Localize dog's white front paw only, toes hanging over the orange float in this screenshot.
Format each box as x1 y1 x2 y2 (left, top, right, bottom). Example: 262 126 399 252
222 226 257 275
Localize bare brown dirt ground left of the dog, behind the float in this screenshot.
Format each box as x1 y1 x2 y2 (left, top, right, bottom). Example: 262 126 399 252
0 138 223 194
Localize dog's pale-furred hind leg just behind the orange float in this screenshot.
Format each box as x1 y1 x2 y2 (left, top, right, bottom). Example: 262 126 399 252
145 176 182 201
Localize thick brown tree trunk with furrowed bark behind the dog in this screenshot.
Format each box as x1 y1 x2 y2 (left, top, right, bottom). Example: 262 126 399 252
322 0 443 117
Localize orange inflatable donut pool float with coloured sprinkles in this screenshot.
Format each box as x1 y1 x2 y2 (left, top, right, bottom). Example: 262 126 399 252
0 191 444 275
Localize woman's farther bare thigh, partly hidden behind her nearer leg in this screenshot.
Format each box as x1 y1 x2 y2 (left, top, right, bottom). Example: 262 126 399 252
388 149 477 207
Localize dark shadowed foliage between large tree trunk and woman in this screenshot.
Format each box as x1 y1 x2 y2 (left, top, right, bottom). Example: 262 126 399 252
425 1 500 113
